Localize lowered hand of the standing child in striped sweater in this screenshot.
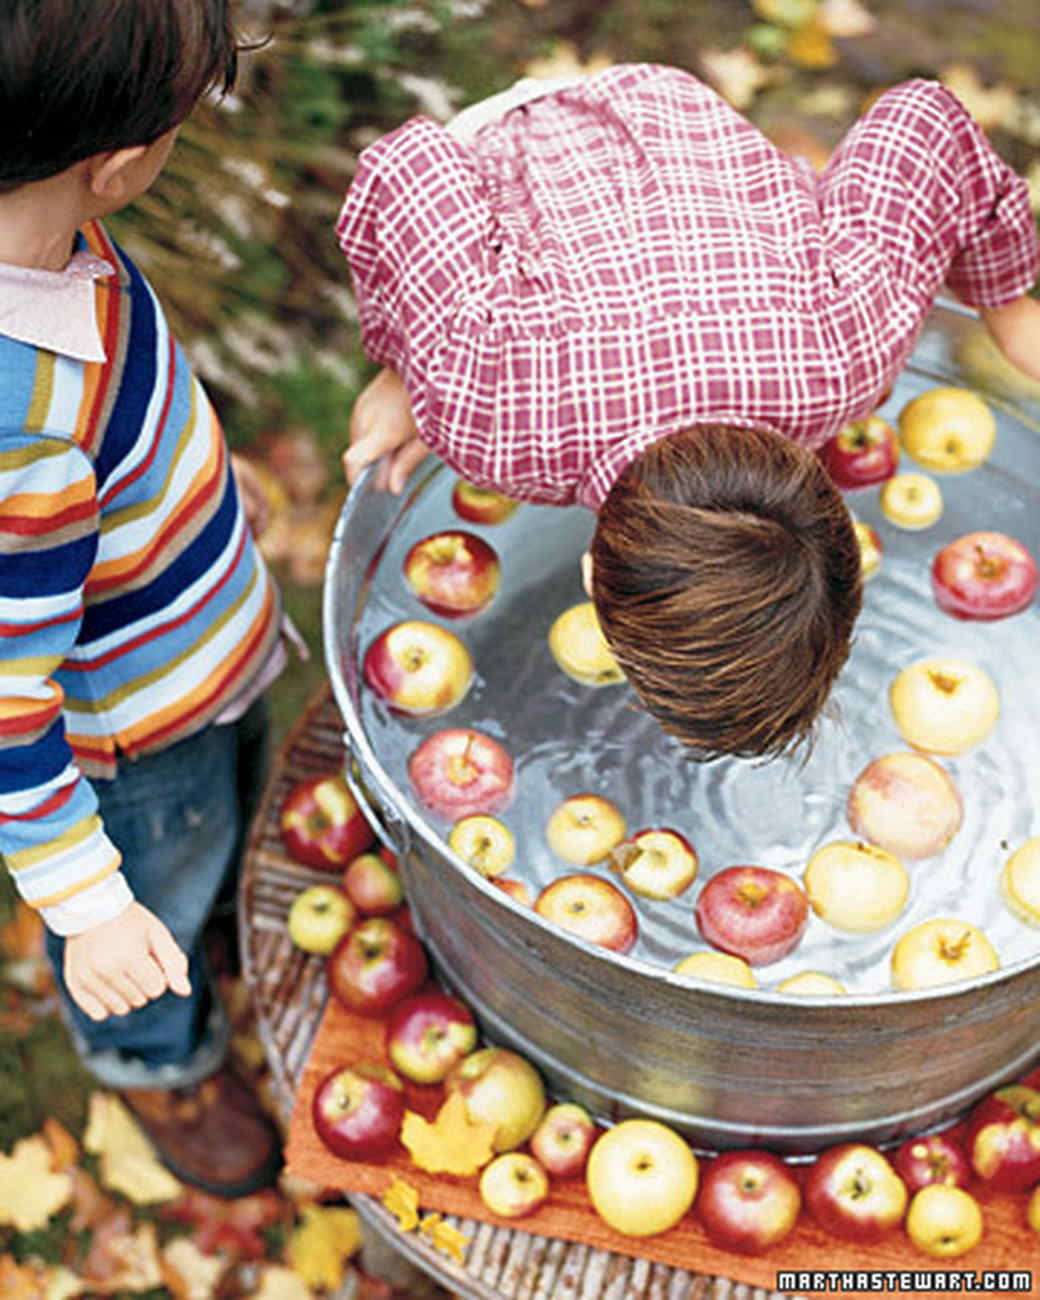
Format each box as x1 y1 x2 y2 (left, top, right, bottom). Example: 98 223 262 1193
65 902 191 1021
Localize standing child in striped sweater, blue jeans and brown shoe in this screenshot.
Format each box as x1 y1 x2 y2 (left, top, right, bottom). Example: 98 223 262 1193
0 0 285 1196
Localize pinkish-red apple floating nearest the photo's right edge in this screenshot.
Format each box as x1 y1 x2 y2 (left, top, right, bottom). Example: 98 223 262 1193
932 532 1037 621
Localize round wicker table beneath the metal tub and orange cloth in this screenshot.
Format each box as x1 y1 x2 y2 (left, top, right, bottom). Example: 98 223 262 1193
238 686 780 1300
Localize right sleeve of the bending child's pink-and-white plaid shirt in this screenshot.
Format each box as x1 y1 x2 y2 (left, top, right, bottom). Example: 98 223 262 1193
822 81 1040 307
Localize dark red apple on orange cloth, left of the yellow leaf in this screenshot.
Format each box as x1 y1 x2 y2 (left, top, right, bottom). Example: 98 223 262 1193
311 1061 404 1160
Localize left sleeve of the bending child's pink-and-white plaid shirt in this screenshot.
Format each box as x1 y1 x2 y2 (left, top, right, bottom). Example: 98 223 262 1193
335 117 490 432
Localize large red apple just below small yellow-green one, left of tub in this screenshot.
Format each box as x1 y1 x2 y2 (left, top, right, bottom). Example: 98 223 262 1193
325 917 428 1015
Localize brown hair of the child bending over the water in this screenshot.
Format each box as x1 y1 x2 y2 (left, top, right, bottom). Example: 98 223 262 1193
592 425 862 758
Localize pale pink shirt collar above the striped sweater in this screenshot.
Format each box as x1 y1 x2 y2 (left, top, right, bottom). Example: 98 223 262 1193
0 234 118 361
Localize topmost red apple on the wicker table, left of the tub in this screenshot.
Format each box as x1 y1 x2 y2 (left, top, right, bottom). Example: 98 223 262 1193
278 772 376 871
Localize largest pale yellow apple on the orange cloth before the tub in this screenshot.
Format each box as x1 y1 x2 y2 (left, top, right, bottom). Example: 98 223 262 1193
585 1119 698 1236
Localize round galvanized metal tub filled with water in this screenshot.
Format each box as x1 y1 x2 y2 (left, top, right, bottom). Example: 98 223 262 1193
324 306 1040 1154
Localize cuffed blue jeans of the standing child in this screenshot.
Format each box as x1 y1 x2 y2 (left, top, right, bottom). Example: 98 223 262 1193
47 699 268 1088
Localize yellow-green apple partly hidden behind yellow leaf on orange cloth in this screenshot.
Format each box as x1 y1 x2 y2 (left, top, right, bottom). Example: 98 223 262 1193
445 1048 546 1152
